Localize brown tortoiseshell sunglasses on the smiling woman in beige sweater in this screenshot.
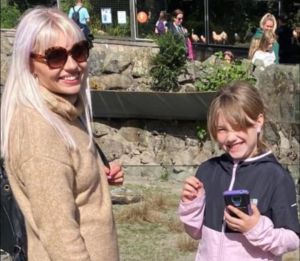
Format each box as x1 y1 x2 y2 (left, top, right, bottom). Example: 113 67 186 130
30 41 89 69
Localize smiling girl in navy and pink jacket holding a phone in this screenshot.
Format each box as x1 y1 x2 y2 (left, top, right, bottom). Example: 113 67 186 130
179 82 299 261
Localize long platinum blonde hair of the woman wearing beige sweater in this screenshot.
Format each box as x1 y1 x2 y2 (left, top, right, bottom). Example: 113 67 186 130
1 7 93 157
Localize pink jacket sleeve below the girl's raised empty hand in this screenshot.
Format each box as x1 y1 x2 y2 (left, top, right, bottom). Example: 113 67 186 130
178 194 205 239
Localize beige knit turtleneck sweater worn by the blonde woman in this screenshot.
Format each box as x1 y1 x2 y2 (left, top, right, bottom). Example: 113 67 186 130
6 90 119 261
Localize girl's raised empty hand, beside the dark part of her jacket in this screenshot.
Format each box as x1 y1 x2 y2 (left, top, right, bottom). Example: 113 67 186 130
181 176 204 202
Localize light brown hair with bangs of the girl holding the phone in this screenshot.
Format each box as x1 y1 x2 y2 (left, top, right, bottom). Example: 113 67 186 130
207 82 269 152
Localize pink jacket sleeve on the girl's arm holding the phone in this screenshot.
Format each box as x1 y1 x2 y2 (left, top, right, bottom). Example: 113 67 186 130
244 216 299 256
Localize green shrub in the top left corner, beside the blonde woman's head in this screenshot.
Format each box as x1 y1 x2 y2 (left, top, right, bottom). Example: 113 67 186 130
1 3 21 29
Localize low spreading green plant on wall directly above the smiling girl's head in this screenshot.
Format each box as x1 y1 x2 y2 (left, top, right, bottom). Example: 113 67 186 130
195 52 256 91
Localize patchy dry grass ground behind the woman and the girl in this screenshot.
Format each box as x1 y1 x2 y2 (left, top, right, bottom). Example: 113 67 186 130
114 172 299 261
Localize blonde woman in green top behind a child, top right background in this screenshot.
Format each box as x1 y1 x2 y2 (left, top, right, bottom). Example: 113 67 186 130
248 13 279 63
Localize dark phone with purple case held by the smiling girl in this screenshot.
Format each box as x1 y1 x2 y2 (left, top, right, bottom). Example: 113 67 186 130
223 189 252 218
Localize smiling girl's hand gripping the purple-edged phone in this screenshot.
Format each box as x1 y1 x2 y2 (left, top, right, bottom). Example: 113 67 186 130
224 204 260 233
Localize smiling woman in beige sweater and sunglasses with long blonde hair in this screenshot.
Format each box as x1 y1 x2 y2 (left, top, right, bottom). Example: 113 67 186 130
1 7 123 261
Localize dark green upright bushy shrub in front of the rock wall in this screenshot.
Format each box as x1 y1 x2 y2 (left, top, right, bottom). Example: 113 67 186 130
150 33 187 91
